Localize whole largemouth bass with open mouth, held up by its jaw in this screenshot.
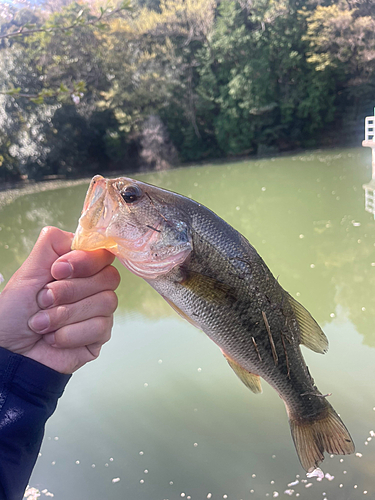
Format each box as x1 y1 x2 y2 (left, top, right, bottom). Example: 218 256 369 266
72 175 354 472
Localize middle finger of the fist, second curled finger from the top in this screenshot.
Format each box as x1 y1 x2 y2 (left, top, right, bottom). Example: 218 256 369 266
37 266 120 309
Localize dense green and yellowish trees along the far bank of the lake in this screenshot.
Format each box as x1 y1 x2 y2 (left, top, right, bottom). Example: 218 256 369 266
0 0 375 180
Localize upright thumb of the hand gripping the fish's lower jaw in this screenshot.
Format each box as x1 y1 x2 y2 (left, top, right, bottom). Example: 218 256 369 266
16 227 73 289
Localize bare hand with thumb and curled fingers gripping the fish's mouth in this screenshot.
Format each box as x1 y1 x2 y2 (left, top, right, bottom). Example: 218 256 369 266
0 227 120 373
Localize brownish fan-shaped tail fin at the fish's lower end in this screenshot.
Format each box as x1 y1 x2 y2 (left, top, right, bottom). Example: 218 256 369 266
289 402 354 472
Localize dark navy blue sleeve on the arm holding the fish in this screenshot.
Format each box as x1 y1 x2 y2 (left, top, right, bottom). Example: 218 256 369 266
0 347 71 500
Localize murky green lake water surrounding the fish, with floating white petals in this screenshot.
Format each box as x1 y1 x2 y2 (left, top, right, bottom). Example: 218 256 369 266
0 148 375 500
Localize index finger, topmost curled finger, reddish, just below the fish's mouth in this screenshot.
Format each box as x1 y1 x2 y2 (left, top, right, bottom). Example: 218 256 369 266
51 250 115 280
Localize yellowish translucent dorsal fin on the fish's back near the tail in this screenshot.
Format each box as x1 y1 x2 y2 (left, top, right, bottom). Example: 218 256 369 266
288 293 328 354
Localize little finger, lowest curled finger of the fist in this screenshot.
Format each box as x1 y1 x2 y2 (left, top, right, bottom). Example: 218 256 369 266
43 315 113 348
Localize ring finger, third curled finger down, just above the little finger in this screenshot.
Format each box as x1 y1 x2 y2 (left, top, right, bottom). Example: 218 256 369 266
29 290 117 334
